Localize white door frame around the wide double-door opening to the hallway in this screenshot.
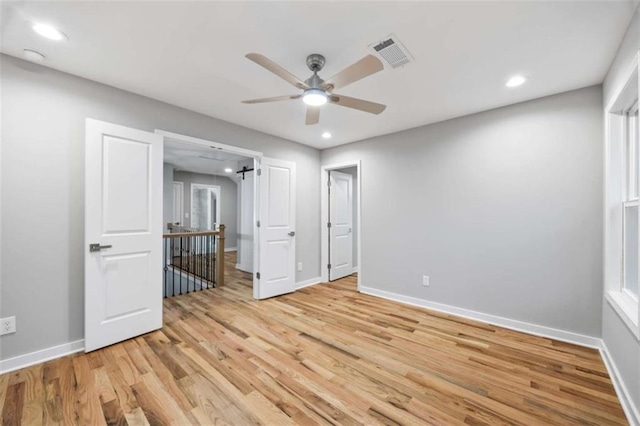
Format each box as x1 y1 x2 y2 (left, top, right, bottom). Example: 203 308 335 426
154 129 262 288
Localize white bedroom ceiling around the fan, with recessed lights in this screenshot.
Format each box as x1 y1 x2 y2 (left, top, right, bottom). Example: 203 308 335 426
1 0 636 148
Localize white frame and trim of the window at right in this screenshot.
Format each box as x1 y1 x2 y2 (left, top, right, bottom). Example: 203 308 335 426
604 55 640 340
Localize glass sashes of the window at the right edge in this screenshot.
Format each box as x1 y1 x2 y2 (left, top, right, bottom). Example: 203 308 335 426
621 100 640 302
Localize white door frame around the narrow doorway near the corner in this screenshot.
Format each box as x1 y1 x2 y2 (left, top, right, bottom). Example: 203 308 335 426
320 160 363 291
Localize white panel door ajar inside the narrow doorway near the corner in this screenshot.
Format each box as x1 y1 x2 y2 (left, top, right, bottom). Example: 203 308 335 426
329 171 353 281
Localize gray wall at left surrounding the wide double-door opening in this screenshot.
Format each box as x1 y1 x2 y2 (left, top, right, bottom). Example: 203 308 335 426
0 55 320 359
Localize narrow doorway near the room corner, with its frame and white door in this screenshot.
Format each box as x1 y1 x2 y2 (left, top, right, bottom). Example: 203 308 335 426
321 160 362 289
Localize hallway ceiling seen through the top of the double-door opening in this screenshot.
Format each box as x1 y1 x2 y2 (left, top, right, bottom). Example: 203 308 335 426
164 138 249 180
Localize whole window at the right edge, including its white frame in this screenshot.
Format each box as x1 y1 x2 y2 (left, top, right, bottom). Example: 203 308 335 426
604 55 640 340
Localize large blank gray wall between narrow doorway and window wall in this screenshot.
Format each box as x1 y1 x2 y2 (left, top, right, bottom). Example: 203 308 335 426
322 86 603 337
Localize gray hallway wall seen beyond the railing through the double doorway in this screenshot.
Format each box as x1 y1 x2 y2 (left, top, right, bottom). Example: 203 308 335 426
173 171 238 248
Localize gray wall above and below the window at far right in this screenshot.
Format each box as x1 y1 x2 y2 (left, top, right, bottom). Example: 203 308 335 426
602 4 640 409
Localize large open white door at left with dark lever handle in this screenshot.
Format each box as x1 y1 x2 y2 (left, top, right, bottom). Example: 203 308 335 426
84 119 163 352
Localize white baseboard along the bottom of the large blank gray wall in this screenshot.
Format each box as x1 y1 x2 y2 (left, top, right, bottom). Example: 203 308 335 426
360 287 601 349
